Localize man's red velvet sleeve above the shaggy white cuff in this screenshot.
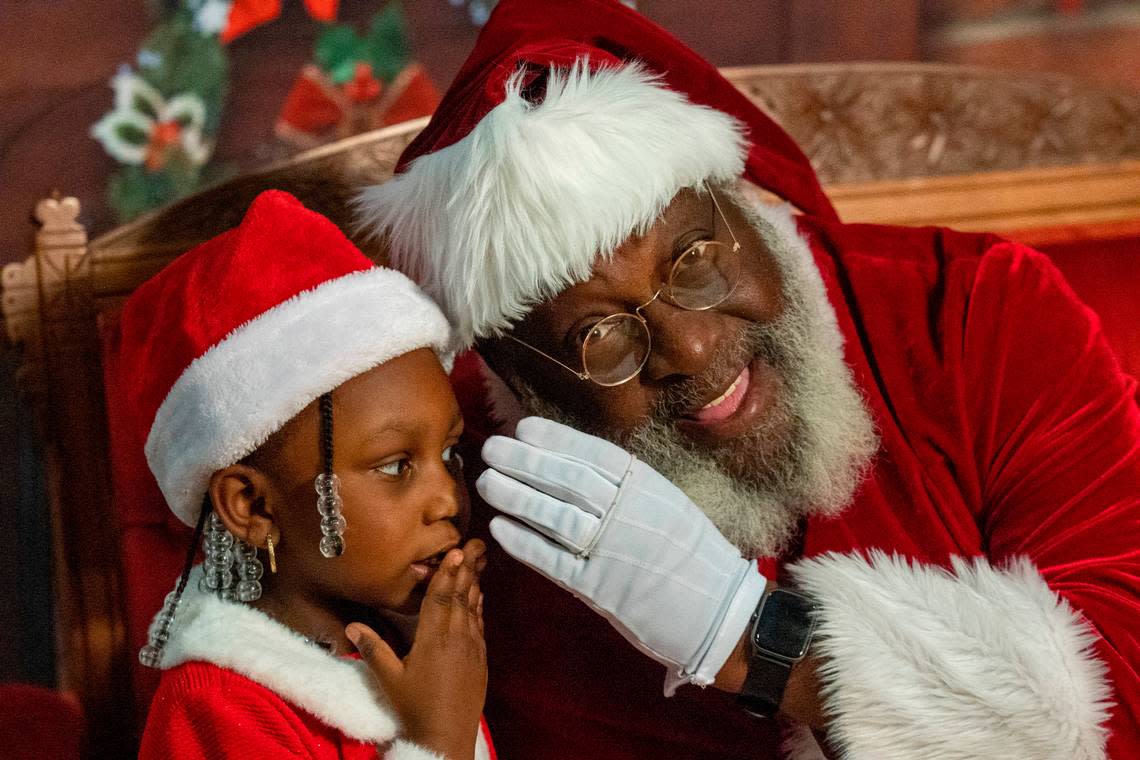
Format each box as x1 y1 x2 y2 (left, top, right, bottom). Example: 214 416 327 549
962 243 1140 758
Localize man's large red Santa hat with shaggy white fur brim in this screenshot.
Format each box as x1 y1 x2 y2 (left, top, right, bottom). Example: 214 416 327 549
358 0 834 345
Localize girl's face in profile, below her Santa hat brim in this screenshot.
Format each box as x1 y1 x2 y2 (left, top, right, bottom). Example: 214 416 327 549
267 349 469 612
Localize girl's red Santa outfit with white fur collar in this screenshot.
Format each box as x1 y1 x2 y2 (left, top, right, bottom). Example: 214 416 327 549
139 569 495 760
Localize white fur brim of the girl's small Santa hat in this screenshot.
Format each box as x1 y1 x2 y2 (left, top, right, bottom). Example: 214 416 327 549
146 268 454 525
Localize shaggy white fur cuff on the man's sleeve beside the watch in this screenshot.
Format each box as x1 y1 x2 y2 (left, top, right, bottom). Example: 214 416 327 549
792 551 1110 760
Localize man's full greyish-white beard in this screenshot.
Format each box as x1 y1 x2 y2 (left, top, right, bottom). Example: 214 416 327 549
487 191 879 557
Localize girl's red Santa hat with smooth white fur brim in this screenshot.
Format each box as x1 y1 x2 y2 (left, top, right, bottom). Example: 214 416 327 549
120 190 451 525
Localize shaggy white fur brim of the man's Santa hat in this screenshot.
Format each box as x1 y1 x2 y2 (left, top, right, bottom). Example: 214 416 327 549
356 62 747 348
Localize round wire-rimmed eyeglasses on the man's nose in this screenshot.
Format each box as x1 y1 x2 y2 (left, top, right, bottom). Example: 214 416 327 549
506 182 740 387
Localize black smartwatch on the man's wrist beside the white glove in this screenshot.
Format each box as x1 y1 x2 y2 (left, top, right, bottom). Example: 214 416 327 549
736 588 815 718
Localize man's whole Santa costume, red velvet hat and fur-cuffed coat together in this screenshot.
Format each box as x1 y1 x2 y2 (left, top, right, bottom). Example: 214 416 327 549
360 0 1140 760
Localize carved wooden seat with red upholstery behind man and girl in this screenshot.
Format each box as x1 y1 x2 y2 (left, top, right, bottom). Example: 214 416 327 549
2 64 1140 758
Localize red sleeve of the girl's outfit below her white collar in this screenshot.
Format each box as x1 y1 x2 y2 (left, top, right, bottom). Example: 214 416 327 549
139 663 328 760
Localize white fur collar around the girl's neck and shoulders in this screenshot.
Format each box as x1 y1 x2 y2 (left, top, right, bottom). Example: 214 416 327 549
161 565 490 760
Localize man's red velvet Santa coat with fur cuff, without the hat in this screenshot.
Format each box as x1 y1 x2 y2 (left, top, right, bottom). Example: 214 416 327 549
449 208 1140 760
